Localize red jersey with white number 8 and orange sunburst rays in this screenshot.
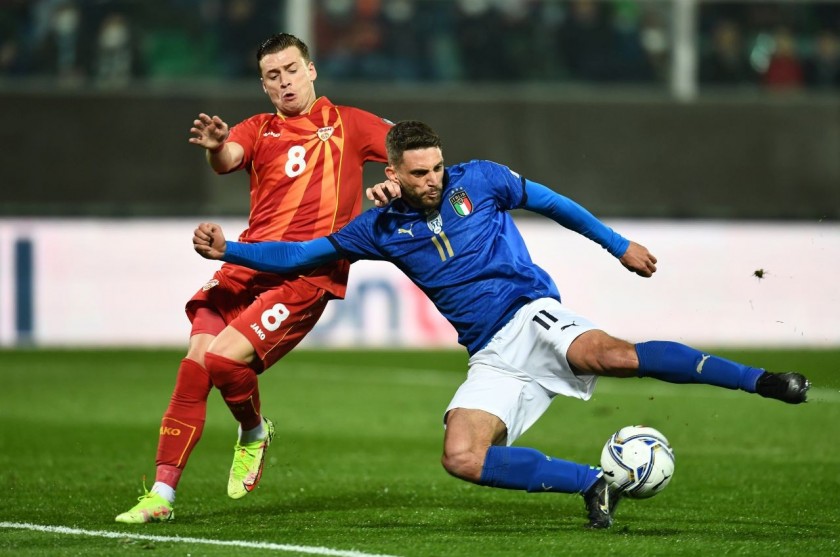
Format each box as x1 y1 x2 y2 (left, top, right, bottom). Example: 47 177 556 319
223 97 392 298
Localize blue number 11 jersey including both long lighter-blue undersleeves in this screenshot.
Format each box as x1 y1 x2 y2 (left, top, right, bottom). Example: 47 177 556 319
224 161 629 354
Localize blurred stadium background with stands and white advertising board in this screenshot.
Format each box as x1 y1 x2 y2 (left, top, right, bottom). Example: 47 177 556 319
0 0 840 346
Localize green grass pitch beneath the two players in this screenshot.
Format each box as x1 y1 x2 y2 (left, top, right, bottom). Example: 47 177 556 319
0 350 840 557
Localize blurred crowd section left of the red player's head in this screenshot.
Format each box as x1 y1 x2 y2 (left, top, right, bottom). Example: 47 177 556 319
0 0 283 87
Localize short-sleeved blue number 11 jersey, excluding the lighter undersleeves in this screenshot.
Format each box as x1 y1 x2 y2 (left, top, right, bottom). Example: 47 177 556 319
329 161 560 354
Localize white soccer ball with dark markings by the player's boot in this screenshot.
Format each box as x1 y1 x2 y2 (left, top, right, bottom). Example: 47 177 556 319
601 425 674 499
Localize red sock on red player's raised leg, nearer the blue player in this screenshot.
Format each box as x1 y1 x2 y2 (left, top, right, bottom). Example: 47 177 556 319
204 352 262 431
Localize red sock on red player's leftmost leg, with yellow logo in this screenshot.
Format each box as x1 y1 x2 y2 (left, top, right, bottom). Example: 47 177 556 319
155 358 213 489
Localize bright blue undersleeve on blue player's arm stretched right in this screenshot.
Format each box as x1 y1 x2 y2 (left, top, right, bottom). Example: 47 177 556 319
522 180 630 257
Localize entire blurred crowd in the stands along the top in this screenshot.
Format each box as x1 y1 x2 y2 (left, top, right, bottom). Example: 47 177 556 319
0 0 840 89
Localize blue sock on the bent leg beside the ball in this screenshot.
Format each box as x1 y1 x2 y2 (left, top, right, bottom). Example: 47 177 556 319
478 446 601 493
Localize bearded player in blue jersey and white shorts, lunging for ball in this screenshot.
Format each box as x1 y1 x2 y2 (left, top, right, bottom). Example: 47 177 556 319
193 121 810 528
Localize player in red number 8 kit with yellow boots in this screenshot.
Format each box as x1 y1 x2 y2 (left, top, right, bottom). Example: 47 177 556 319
116 33 392 523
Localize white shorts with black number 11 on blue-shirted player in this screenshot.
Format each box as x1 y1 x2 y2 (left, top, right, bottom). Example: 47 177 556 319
446 298 597 445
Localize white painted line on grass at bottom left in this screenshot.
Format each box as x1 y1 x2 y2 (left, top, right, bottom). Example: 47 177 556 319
0 522 396 557
